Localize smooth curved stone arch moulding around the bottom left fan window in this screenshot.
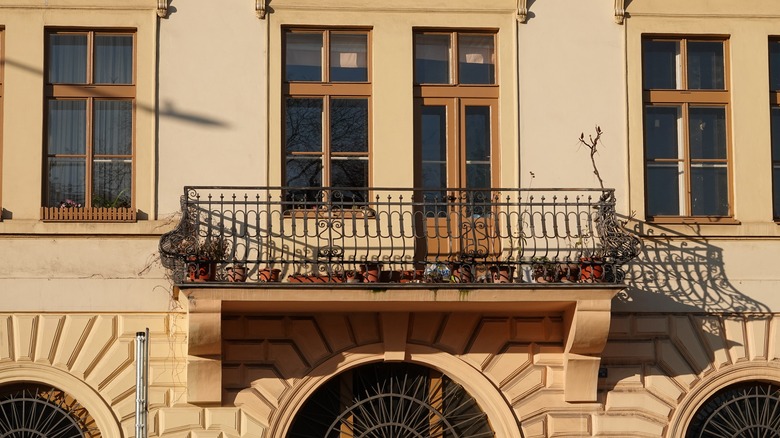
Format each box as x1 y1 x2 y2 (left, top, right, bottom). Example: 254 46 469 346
0 363 124 438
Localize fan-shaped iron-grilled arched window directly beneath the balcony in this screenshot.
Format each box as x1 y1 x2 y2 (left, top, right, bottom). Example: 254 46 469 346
288 363 495 438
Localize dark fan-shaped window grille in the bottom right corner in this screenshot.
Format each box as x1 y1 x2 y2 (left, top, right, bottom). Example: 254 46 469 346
686 382 780 438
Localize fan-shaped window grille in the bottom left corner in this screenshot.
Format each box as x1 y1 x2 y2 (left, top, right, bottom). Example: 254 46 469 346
0 384 100 438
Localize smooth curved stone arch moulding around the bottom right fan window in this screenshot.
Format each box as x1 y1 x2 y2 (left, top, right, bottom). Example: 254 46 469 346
665 362 780 438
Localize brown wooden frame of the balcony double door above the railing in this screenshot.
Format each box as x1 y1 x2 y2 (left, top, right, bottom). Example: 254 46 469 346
413 29 500 188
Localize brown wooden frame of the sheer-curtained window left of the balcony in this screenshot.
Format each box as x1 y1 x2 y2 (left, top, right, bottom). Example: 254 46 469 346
41 28 138 222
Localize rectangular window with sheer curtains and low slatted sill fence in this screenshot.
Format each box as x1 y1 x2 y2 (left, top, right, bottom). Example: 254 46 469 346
42 30 135 221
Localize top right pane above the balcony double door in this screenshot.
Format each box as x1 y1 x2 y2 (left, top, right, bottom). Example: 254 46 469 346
458 35 496 84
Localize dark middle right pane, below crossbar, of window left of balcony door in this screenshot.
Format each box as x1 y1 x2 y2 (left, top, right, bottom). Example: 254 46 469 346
330 99 368 152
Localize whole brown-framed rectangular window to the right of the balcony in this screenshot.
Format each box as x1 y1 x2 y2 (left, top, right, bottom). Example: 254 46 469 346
642 37 733 218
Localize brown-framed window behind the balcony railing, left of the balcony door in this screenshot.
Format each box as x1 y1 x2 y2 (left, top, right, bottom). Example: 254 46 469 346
283 29 371 203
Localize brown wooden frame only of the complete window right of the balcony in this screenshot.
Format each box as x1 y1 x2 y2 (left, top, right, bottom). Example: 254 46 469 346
642 35 736 223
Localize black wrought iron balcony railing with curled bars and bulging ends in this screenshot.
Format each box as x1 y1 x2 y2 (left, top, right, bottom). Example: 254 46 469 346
160 187 640 284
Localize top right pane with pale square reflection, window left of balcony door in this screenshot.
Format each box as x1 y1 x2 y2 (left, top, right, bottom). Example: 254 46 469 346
330 33 368 82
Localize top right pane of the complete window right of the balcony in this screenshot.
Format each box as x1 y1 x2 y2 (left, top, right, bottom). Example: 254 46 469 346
688 41 724 90
